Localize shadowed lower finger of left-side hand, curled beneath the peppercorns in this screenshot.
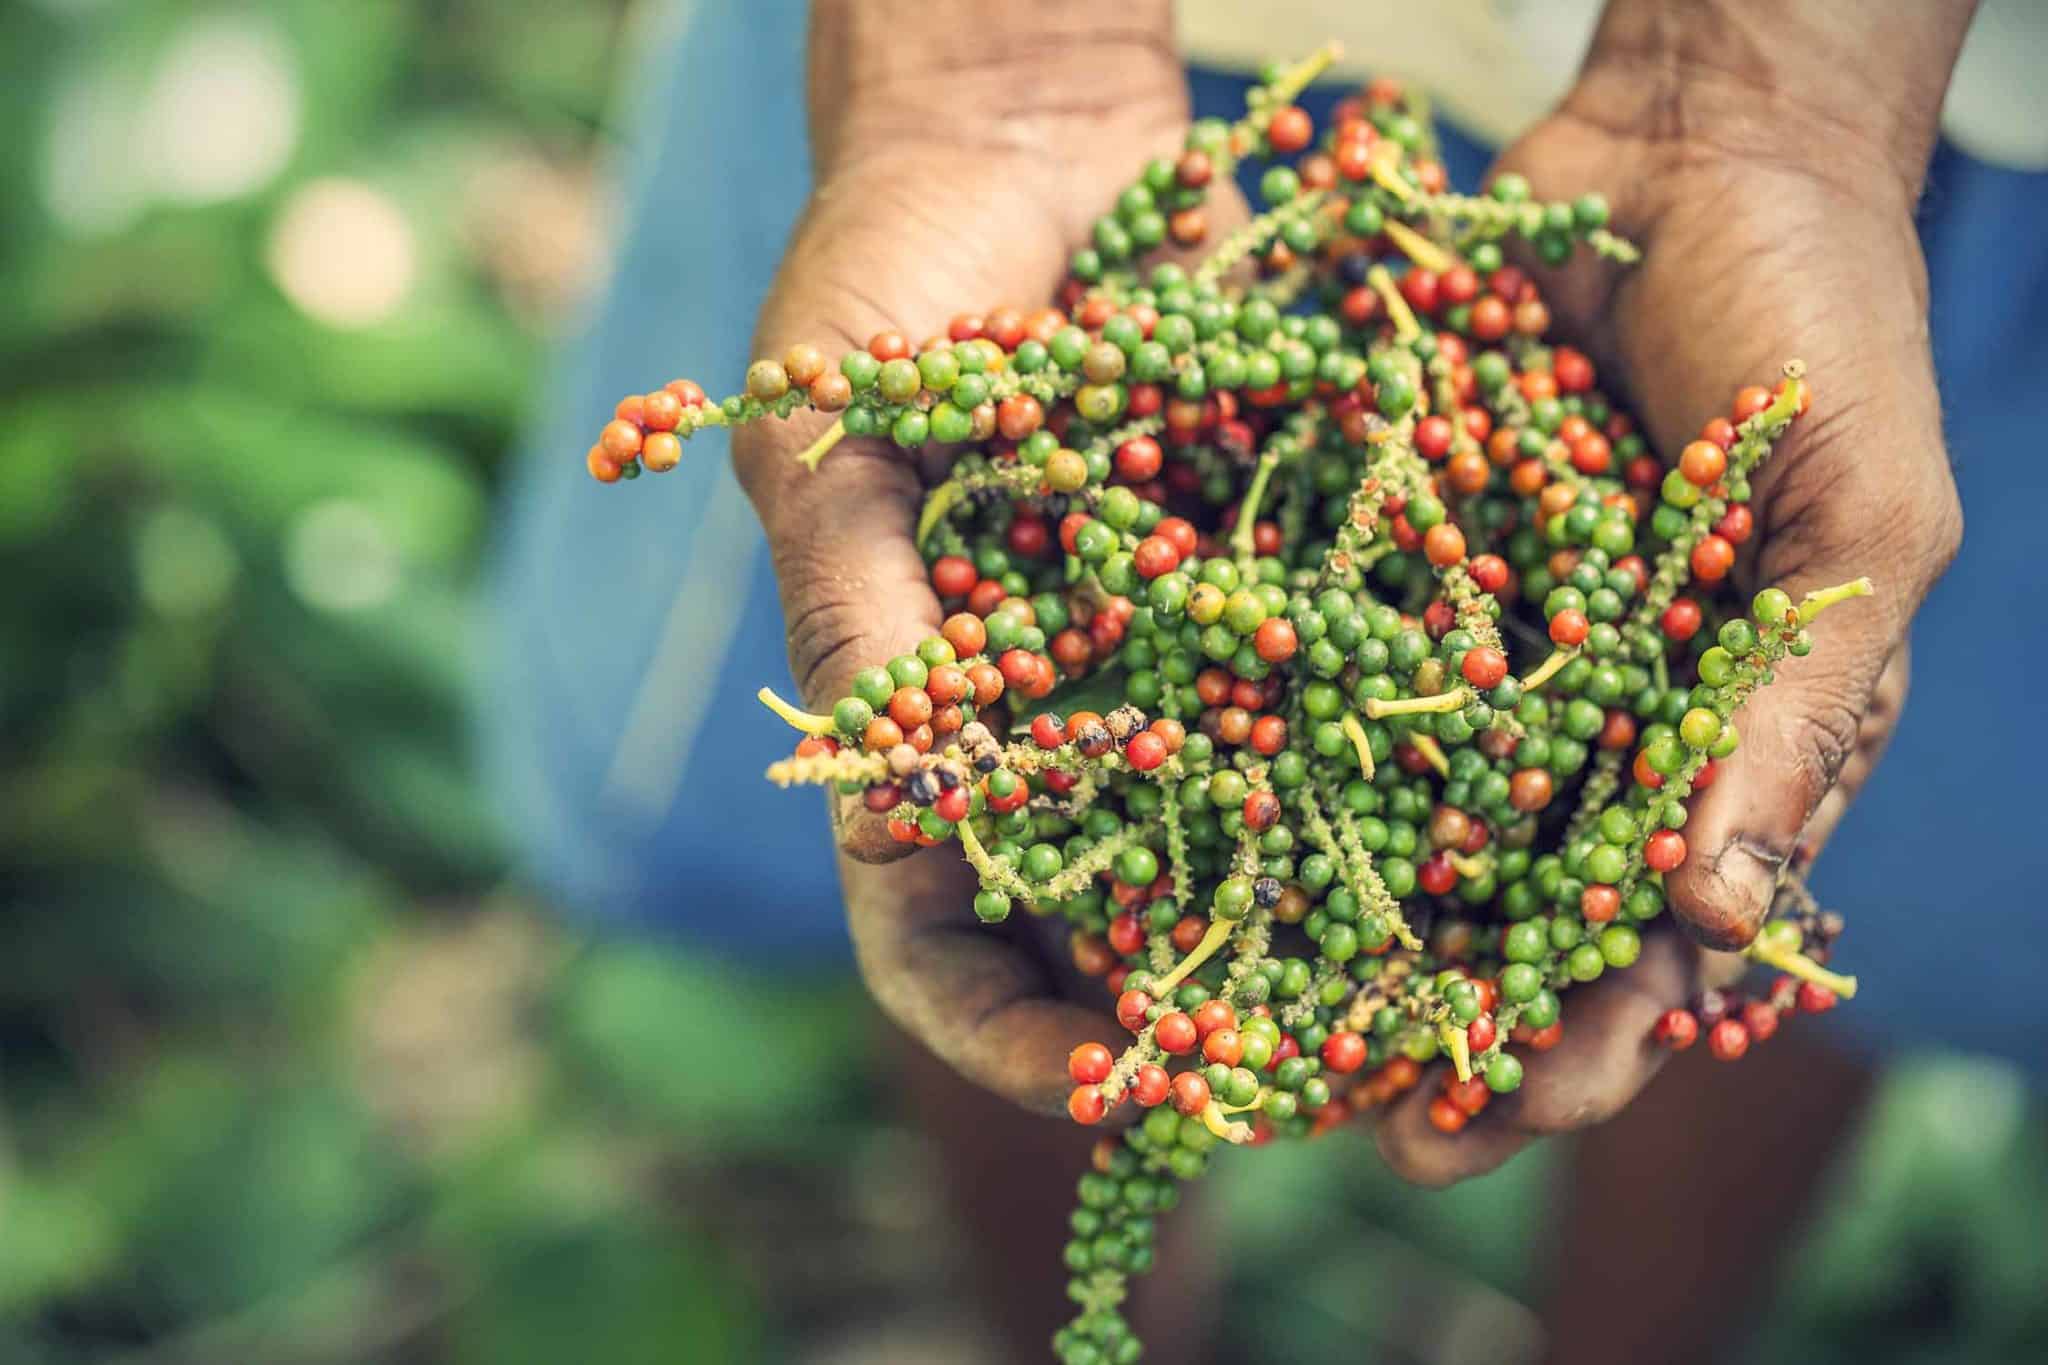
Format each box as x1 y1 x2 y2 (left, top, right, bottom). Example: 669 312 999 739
840 849 1106 1113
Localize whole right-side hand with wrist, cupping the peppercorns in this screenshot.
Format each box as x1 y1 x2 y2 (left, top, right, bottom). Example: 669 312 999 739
1380 4 1968 1183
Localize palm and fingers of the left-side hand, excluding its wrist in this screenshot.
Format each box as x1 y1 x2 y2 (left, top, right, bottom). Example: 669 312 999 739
733 68 1220 1109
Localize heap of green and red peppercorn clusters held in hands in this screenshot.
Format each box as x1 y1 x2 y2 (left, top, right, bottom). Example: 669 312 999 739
588 55 1868 1365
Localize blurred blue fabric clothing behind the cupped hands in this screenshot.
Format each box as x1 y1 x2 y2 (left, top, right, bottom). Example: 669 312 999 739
485 13 2048 1064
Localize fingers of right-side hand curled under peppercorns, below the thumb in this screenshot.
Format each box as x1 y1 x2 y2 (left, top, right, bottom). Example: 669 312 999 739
1378 933 1743 1187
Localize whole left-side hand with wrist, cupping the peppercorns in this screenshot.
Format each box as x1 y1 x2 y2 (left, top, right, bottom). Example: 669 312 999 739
733 0 1212 1109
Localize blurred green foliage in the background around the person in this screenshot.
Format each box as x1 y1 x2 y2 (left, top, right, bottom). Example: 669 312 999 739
0 0 2048 1365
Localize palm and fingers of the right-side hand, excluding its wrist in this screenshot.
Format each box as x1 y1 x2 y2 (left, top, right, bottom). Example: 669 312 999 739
1380 114 1954 1183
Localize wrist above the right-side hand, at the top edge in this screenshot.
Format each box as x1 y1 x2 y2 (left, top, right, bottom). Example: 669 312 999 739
1565 0 1976 205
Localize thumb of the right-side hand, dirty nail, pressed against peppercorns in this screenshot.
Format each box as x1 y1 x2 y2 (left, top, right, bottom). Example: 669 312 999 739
1667 389 1962 948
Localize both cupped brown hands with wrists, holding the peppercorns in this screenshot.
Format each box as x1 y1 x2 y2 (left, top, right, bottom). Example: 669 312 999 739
733 0 1972 1185
